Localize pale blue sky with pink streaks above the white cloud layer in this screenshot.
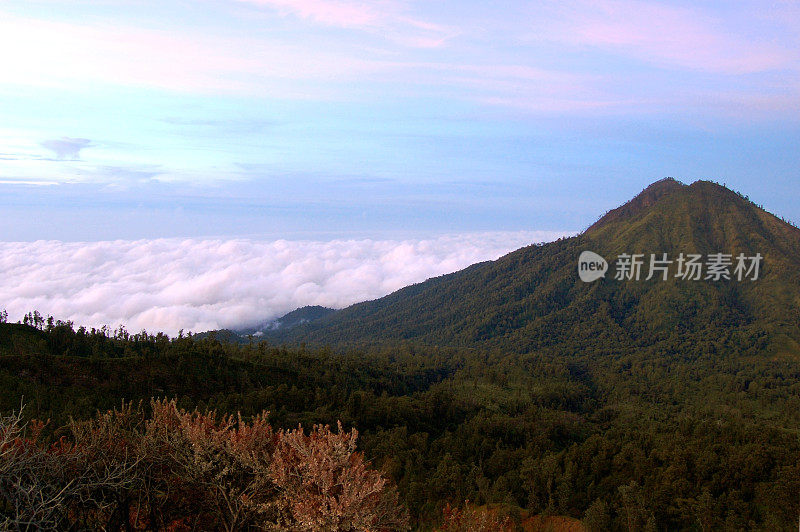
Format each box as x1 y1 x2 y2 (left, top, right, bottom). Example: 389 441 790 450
0 0 800 241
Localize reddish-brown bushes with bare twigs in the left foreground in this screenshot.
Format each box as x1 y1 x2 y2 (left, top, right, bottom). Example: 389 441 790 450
0 400 408 531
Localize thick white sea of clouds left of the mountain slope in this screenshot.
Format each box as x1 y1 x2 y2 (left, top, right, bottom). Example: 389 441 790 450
0 231 566 335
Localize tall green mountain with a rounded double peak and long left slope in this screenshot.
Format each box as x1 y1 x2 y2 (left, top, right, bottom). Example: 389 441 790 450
265 179 800 356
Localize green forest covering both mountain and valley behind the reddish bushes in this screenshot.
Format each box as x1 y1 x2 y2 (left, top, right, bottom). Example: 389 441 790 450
0 180 800 531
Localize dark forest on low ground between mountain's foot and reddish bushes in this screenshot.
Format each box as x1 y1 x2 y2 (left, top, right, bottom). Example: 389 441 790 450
0 314 800 530
